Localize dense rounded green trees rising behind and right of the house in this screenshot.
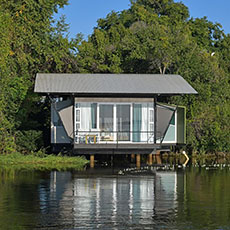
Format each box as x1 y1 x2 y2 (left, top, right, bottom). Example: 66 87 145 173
77 0 230 153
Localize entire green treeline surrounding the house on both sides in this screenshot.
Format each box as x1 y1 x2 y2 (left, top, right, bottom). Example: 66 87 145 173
0 0 230 153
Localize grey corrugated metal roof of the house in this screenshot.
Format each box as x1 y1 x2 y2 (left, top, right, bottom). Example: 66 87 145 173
34 73 197 95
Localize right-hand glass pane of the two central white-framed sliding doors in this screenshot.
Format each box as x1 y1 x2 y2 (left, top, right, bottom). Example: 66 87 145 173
116 105 130 141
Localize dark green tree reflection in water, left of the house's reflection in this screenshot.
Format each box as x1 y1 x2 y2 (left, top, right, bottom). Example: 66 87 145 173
0 168 44 230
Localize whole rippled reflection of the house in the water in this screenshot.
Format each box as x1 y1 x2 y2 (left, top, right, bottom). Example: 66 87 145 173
46 172 183 229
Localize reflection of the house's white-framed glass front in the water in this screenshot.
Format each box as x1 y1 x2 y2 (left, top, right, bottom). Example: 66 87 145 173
69 178 154 228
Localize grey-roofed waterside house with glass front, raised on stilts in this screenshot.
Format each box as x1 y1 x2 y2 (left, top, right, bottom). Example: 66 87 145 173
34 73 197 154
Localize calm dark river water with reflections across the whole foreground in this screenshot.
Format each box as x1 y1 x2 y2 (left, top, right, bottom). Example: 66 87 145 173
0 167 230 230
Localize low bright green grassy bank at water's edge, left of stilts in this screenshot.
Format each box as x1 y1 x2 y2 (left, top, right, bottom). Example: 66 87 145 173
0 153 88 170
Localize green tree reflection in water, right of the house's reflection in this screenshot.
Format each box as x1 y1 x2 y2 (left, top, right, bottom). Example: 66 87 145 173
178 168 230 229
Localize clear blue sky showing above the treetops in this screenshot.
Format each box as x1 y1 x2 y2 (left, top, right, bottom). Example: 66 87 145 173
56 0 230 38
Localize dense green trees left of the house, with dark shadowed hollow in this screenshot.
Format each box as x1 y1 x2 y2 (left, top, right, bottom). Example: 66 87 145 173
0 0 76 153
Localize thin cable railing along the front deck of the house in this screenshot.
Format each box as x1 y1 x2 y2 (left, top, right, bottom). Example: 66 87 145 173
74 130 161 144
